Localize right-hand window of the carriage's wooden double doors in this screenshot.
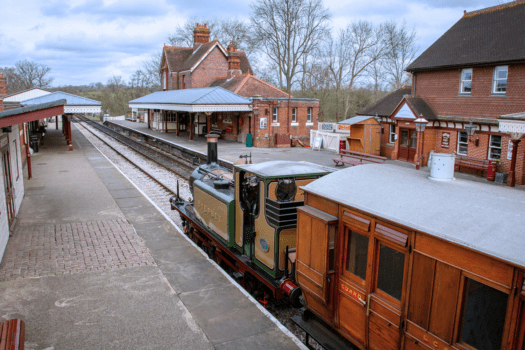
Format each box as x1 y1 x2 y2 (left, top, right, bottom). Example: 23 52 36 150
377 244 405 300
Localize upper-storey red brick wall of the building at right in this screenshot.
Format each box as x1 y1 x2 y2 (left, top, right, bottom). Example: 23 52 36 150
415 64 525 118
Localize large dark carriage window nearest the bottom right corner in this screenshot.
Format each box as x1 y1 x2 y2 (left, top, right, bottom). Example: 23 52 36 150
460 278 508 350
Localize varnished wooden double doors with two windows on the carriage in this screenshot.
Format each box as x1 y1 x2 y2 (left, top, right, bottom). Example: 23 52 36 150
337 211 408 350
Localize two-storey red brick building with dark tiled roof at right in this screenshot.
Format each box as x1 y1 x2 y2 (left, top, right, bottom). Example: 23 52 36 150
358 0 525 185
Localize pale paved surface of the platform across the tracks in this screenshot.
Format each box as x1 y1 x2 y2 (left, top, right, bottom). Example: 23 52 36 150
111 120 525 191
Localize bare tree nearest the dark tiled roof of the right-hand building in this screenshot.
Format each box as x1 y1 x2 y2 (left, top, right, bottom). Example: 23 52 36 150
383 21 418 89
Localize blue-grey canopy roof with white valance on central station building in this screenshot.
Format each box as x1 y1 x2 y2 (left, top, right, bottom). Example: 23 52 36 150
129 86 252 113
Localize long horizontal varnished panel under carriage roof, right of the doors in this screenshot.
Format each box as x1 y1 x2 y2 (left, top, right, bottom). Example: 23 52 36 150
415 233 514 289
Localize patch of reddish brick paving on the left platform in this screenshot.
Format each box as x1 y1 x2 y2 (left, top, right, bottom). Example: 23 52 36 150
0 220 155 282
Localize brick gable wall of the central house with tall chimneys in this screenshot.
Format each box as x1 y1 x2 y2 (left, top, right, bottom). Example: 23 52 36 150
190 47 228 89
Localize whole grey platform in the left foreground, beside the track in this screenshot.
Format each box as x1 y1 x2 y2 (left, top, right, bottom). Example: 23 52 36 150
0 126 304 350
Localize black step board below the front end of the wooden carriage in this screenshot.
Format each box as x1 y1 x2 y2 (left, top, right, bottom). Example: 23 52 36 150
292 310 358 350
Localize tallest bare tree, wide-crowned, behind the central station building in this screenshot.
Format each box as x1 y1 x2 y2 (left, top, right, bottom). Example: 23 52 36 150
250 0 330 91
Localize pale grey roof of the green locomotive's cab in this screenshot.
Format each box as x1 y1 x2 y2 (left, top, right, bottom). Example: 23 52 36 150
235 160 334 178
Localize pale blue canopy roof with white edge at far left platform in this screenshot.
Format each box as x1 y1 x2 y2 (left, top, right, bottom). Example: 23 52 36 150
20 91 102 114
